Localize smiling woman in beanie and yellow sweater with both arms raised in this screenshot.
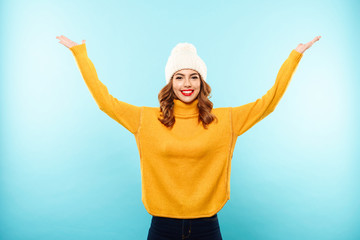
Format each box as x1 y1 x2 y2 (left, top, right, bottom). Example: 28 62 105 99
56 35 320 240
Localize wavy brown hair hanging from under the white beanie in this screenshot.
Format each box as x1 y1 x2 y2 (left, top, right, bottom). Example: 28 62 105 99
158 74 218 129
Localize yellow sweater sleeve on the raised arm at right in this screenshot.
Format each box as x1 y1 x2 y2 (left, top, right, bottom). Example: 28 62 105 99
231 49 303 136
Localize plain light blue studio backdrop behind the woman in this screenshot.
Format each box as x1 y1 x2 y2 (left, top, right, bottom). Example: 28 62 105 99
0 0 360 240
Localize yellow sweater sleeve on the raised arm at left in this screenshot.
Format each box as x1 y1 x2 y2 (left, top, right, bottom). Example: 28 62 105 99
70 43 142 134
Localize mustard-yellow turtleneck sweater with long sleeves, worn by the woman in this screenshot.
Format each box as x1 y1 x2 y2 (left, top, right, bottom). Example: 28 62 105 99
70 44 303 218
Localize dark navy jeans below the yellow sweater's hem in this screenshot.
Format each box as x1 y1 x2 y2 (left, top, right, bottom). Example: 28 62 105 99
147 214 222 240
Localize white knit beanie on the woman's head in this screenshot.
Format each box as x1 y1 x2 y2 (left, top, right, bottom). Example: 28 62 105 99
165 42 207 84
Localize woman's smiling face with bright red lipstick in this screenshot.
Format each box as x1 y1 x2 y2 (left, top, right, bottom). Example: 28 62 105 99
172 69 201 103
